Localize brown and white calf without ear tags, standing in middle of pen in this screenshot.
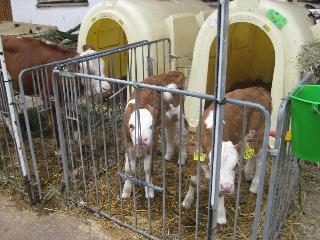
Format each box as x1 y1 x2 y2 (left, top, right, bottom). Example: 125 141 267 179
122 71 187 198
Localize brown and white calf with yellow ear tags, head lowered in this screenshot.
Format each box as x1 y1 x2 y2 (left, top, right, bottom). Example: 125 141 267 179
182 87 272 224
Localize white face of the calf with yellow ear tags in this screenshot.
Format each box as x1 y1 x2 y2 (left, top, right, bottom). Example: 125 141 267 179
219 141 238 193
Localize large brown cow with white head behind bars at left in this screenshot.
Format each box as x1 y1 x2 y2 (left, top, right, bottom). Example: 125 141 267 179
2 36 111 151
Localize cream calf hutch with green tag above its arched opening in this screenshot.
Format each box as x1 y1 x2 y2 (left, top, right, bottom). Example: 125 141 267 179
186 0 318 129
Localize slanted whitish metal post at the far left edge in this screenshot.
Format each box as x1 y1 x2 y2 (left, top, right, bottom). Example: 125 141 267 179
0 37 33 201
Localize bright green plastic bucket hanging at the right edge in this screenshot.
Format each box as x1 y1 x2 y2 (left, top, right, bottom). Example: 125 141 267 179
291 85 320 162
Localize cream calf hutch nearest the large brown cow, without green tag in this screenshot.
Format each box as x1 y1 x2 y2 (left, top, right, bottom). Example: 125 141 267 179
78 0 213 81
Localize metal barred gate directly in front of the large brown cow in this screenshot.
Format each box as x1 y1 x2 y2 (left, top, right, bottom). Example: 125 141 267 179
17 40 165 201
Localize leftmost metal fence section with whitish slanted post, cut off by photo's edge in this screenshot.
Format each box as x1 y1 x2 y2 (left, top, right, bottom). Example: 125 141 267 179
0 38 32 199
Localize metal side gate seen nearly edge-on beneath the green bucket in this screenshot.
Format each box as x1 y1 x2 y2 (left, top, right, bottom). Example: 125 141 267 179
264 72 312 239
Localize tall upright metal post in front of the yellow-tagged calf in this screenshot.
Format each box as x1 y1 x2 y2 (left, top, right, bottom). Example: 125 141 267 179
207 0 229 239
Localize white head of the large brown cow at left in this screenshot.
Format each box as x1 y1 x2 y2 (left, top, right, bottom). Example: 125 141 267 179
80 45 112 95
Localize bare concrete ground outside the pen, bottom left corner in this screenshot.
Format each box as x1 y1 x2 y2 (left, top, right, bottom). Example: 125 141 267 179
0 191 137 240
